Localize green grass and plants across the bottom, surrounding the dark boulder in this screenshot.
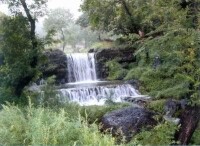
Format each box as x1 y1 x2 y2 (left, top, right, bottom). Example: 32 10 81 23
0 102 199 146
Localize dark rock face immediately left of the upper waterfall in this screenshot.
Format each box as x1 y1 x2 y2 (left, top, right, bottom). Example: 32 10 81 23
40 49 68 84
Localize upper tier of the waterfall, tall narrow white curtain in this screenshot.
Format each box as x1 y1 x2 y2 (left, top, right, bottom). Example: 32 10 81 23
67 53 97 82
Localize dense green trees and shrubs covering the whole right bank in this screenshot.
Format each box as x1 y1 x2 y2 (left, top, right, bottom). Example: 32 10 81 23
82 0 200 102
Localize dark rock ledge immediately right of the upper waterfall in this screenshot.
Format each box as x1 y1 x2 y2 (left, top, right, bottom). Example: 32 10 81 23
94 48 136 79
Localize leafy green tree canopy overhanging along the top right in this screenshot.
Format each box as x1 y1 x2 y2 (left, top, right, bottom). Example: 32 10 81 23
81 0 197 35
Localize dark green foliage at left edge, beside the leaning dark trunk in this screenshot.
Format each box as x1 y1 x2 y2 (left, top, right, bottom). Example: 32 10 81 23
1 16 38 102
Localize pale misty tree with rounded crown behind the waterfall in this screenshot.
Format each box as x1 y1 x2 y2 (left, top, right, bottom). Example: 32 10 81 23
44 8 73 51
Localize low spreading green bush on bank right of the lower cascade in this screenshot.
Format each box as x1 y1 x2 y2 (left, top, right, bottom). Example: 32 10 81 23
125 65 189 99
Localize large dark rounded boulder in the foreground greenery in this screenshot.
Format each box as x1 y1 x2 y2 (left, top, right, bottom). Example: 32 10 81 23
101 107 156 141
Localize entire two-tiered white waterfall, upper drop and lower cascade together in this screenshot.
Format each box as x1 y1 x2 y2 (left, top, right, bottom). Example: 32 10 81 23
59 53 138 105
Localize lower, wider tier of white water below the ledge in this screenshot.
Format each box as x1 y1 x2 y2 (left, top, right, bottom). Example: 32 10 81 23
57 84 138 105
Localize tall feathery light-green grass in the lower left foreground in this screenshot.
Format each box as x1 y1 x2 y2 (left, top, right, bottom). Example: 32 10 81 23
0 105 114 146
